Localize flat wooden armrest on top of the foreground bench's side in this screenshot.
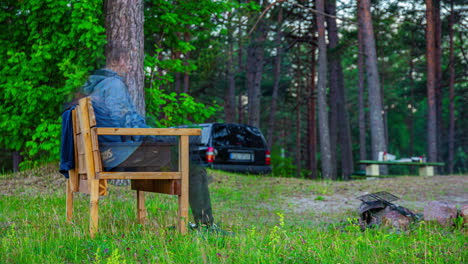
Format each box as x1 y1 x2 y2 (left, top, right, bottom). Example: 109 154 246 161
97 127 201 136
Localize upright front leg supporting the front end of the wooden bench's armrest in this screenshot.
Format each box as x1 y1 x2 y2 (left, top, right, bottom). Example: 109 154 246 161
178 136 189 234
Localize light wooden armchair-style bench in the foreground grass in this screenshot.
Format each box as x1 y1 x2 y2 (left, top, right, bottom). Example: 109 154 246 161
66 97 201 237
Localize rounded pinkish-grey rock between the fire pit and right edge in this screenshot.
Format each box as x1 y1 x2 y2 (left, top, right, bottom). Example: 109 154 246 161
424 201 458 226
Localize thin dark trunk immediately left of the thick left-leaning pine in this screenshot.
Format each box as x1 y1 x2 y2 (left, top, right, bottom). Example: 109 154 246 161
358 0 367 170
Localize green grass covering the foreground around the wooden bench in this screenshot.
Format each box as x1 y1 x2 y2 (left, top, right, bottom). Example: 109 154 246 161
0 168 468 263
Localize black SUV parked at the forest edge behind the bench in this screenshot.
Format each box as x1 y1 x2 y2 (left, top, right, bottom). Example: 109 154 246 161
178 123 271 174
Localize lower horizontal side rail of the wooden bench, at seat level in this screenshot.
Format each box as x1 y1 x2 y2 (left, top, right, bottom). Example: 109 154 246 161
97 171 182 180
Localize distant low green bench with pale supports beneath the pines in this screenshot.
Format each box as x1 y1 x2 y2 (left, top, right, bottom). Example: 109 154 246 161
359 160 444 176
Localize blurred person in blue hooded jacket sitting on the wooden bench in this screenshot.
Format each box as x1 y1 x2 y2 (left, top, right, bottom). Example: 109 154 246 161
61 69 213 226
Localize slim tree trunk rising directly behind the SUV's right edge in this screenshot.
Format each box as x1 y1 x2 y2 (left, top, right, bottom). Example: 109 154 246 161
267 4 283 150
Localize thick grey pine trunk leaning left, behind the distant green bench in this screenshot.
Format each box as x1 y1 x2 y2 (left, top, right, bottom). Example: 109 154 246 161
358 0 387 174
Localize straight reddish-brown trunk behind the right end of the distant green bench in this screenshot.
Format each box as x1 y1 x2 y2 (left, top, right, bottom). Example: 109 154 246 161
426 0 437 162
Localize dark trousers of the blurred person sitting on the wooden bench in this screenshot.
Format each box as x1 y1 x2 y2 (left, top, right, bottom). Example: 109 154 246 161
111 143 214 225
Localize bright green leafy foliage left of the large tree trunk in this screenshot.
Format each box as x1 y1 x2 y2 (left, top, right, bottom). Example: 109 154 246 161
0 0 105 167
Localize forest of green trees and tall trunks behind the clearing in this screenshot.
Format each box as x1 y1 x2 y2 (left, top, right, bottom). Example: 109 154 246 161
0 0 468 179
